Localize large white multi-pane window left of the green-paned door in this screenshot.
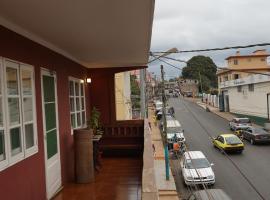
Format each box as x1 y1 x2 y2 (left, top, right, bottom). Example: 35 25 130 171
0 58 38 170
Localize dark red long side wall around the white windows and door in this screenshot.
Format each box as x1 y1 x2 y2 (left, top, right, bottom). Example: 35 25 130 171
0 26 89 200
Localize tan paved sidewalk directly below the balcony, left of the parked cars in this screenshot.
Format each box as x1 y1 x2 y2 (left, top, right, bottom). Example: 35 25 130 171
149 109 179 200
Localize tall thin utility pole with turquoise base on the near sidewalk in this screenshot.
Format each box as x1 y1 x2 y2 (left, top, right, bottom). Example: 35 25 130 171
160 65 170 181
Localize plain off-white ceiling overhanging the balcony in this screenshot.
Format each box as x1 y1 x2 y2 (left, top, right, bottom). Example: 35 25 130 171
0 0 154 68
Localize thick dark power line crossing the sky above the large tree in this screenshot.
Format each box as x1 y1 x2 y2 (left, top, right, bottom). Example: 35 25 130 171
150 43 270 55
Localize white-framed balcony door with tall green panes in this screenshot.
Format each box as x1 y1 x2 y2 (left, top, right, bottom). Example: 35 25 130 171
42 70 61 199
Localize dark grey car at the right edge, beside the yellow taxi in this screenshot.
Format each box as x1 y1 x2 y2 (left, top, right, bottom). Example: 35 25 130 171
242 127 270 144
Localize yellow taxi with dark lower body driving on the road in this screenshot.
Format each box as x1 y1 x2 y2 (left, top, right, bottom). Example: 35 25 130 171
213 134 244 153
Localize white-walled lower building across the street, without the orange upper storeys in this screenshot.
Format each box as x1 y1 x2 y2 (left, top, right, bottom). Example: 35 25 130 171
219 73 270 119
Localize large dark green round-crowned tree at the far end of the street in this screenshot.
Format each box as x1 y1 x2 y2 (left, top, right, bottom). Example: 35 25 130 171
182 56 217 91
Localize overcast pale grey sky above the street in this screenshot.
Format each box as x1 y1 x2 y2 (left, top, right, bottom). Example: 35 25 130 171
149 0 270 78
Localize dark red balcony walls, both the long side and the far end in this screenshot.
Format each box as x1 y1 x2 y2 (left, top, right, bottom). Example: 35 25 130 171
0 26 146 200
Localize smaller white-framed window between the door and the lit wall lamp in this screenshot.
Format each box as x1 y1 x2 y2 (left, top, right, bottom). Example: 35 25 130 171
69 78 86 129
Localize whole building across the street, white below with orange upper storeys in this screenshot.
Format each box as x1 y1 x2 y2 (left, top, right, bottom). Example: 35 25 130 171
217 50 270 119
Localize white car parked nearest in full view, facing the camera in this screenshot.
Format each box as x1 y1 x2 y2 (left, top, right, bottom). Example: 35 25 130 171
180 151 215 185
